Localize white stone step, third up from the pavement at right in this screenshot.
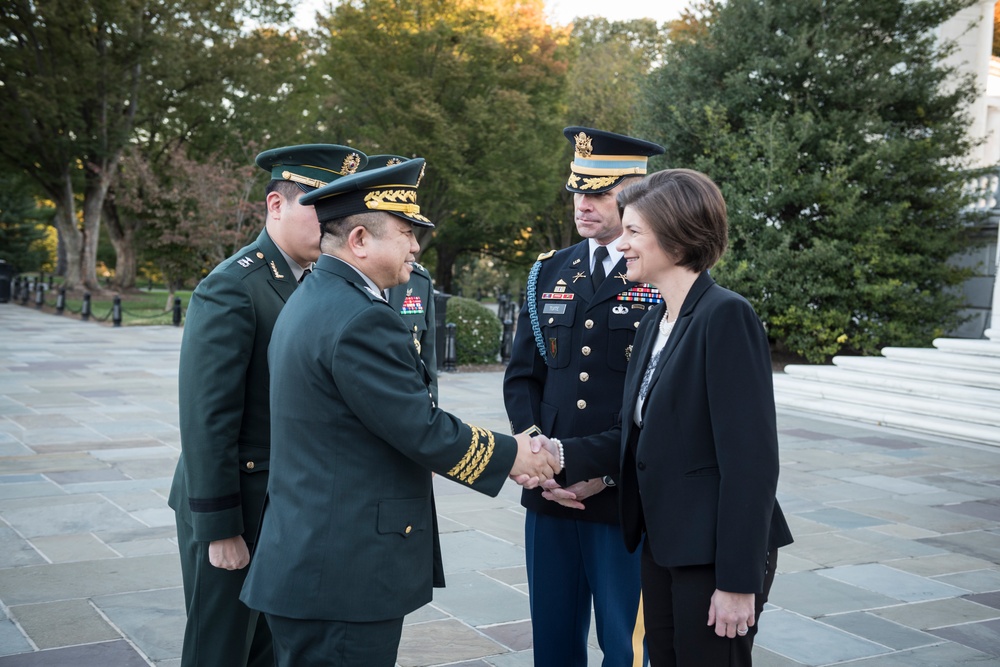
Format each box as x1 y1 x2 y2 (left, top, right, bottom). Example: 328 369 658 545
785 364 1000 411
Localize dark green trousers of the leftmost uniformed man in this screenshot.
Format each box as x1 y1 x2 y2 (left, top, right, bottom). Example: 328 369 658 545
177 517 274 667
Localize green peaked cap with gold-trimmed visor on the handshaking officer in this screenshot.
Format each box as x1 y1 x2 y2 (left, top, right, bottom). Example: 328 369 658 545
299 157 434 227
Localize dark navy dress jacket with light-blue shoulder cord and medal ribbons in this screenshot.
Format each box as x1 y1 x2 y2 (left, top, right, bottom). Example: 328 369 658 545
503 241 661 523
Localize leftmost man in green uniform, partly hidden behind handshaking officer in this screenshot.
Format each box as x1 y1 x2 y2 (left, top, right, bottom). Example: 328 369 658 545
169 144 367 667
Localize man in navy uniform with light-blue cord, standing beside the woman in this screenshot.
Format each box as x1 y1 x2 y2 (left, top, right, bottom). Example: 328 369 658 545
504 127 663 667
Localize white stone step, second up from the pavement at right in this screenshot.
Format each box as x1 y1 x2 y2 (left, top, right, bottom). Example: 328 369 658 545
774 374 1000 429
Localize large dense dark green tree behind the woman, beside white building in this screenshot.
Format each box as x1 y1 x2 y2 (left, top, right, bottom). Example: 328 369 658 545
647 0 975 361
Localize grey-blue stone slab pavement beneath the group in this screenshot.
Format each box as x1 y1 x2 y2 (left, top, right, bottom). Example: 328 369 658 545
0 304 1000 667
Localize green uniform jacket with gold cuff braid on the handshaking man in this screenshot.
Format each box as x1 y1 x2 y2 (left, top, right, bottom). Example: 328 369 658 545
240 255 517 622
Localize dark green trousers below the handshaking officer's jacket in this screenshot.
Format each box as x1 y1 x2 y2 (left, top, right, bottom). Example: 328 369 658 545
265 614 403 667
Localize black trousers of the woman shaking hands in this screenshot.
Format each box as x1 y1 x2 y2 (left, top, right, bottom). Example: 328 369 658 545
642 543 778 667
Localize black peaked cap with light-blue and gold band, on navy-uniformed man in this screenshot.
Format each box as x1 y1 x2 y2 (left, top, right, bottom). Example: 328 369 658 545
563 125 663 194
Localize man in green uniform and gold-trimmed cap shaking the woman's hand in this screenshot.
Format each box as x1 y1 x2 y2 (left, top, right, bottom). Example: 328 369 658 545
241 158 558 667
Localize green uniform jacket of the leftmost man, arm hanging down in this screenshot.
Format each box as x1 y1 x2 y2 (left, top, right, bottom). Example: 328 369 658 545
168 230 297 544
